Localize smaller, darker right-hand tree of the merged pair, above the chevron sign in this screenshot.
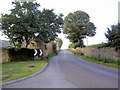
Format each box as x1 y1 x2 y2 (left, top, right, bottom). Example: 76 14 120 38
36 9 63 43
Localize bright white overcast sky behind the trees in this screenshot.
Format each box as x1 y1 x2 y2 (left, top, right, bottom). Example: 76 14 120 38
0 0 120 49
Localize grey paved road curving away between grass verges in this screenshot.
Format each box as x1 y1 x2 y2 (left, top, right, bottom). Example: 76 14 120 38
3 51 118 88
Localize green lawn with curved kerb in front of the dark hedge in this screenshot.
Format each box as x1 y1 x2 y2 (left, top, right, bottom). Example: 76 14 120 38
2 60 47 82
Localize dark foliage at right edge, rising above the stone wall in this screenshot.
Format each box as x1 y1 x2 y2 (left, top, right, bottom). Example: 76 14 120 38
105 23 120 49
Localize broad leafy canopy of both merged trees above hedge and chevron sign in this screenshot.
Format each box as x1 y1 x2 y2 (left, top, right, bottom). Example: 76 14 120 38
1 2 63 48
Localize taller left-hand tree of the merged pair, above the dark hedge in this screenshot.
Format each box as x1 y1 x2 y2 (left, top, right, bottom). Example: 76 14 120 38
1 2 40 48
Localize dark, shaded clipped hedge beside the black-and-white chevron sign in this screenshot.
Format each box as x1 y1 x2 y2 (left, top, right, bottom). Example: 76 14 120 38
8 48 34 62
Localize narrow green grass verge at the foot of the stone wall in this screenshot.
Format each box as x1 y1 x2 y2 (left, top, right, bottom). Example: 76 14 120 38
68 50 120 69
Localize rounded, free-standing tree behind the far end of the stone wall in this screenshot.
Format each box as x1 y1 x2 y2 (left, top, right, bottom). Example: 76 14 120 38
63 11 96 47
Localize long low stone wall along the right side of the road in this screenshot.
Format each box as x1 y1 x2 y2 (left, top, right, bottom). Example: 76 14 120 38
71 48 120 60
